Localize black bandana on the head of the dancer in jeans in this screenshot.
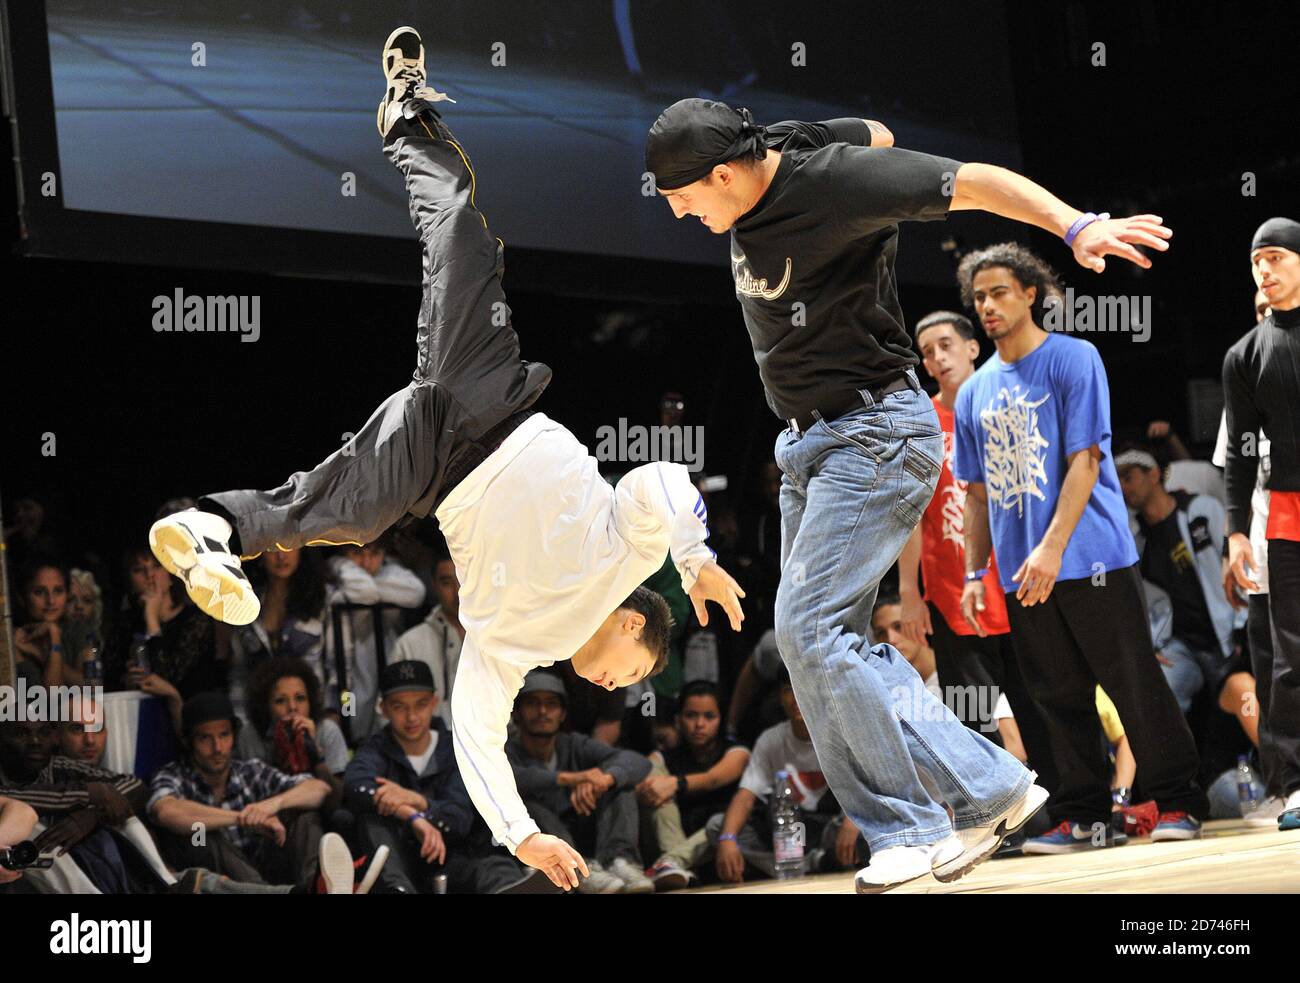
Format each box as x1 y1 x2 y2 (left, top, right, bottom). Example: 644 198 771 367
646 99 767 191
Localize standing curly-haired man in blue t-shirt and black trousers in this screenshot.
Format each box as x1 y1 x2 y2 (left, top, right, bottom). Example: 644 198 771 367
953 243 1206 853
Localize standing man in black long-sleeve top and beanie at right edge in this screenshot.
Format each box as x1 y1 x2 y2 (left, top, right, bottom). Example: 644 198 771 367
1223 218 1300 830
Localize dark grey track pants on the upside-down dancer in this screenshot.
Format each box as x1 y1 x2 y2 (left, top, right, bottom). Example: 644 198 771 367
199 111 551 557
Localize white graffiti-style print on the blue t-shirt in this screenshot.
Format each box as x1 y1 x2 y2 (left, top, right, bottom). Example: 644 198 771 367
979 385 1052 515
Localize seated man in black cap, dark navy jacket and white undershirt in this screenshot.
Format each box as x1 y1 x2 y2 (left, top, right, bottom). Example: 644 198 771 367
343 659 543 895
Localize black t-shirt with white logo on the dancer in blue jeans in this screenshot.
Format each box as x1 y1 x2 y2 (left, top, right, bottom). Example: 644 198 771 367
731 120 961 419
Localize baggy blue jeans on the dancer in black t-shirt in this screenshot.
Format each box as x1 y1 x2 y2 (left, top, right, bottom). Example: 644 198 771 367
776 376 1031 852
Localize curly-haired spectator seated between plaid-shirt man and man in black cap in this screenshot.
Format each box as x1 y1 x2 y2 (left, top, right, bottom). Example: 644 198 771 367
235 655 347 815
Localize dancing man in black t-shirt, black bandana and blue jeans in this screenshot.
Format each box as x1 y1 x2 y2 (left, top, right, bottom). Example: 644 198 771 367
646 99 1171 893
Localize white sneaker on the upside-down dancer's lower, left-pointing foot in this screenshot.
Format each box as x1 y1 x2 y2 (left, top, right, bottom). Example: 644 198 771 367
150 508 261 624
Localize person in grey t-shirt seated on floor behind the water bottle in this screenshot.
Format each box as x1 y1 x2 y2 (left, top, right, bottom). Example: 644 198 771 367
706 667 868 883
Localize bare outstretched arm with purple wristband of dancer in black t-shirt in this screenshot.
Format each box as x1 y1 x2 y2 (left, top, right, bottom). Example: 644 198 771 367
952 164 1174 273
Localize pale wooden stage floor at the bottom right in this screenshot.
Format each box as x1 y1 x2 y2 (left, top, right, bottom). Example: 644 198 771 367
676 819 1300 895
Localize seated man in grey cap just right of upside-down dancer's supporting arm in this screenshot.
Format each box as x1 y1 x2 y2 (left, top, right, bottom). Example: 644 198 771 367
506 670 654 895
